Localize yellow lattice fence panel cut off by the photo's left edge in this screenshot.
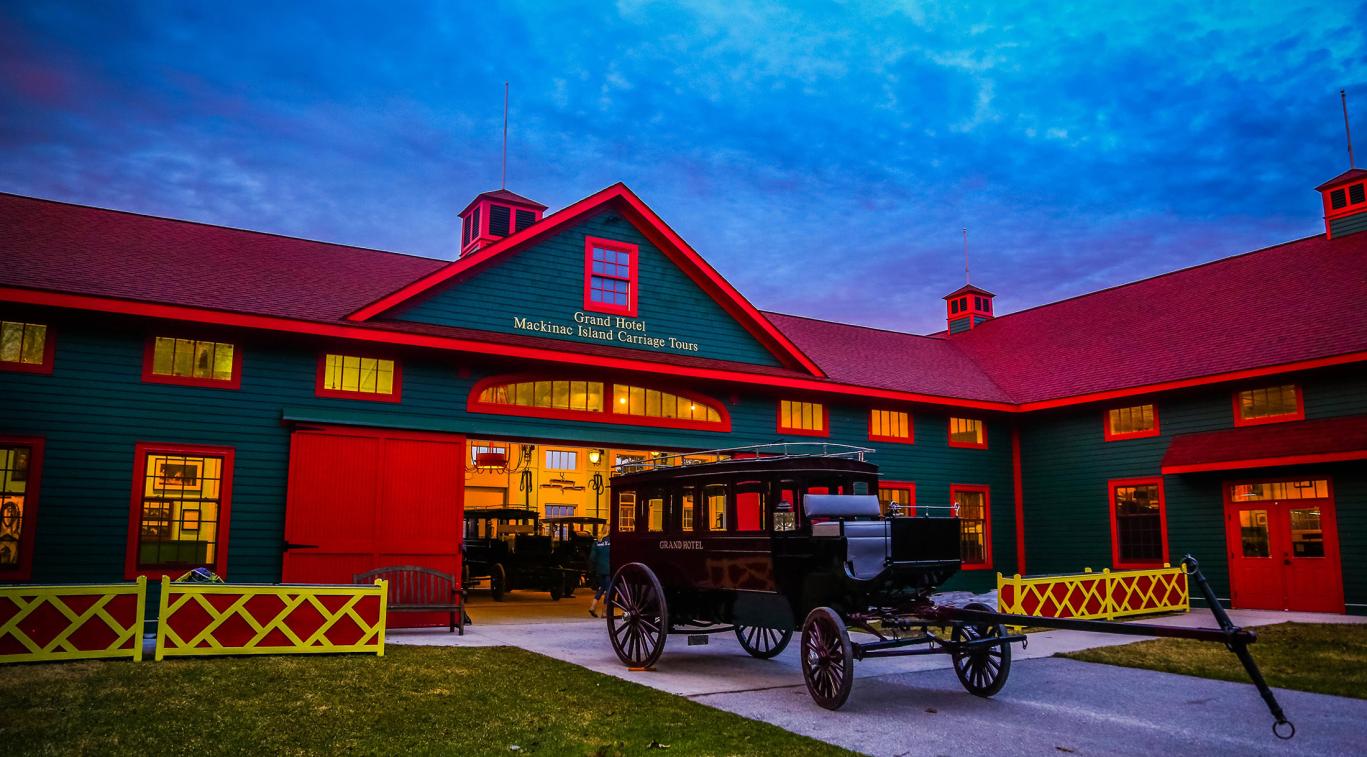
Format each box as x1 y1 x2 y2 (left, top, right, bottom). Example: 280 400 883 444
0 578 148 663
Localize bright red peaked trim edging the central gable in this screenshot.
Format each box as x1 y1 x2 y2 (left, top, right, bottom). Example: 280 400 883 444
347 182 823 376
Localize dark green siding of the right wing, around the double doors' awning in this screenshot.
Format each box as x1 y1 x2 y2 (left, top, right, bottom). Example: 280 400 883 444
1021 368 1367 611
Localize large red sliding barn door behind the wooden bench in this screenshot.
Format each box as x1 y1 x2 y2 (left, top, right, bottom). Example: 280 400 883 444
283 428 465 624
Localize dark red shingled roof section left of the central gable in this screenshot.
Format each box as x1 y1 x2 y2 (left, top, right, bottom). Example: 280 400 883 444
0 193 446 321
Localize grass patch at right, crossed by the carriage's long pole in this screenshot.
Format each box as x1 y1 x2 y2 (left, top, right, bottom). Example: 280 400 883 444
1061 623 1367 700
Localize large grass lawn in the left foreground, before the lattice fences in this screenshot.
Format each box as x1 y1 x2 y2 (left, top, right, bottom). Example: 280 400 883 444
0 646 848 756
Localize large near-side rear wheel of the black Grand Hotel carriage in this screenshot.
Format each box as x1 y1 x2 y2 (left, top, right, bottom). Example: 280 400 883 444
607 563 670 668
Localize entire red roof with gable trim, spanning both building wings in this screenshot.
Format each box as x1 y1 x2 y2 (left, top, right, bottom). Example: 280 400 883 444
0 184 1367 411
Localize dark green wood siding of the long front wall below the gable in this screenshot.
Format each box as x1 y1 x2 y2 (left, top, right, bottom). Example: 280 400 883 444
0 306 1014 590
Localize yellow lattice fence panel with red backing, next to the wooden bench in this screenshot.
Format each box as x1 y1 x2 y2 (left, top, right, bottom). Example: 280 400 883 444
156 578 388 660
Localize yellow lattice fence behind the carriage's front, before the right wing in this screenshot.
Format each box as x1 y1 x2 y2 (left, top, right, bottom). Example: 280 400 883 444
997 563 1191 620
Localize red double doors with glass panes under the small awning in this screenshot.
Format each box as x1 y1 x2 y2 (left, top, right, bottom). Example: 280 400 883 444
1225 478 1344 612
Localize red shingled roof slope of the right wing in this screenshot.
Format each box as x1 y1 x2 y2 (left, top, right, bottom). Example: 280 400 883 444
946 234 1367 406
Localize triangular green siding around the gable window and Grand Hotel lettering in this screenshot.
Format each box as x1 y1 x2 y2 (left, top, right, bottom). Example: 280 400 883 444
384 212 779 365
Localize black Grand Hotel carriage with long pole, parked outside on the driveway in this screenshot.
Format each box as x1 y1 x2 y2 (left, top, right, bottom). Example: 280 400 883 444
607 443 1295 738
